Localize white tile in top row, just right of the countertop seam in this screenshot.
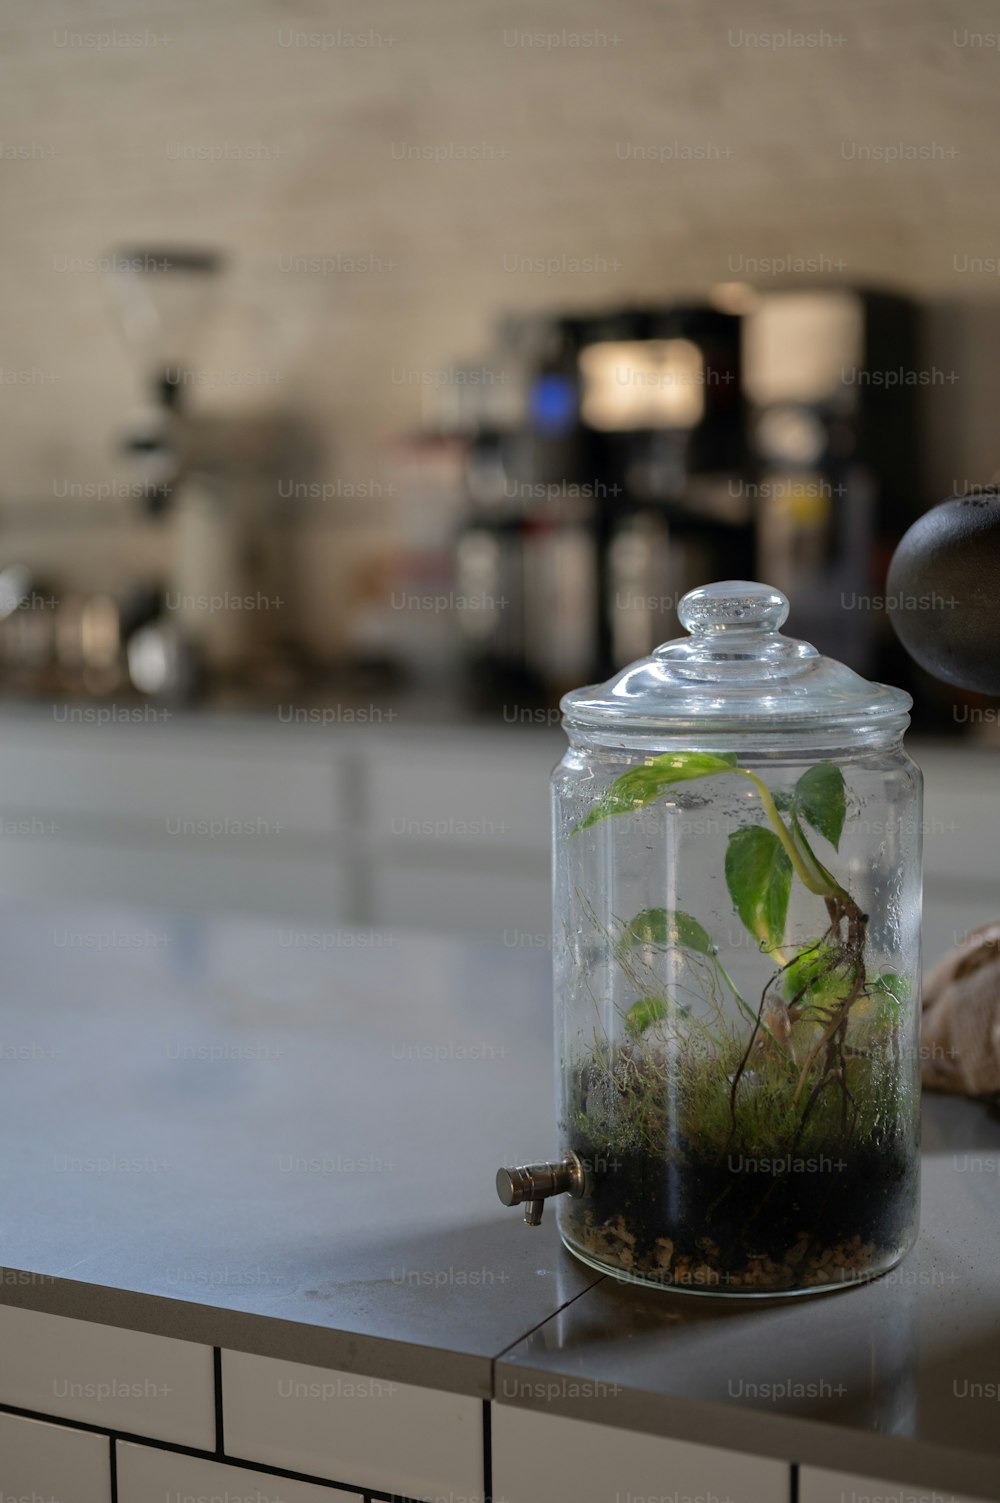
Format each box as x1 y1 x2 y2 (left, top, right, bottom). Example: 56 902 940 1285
493 1404 791 1503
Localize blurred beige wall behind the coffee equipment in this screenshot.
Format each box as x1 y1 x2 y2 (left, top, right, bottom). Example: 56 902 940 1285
0 0 1000 652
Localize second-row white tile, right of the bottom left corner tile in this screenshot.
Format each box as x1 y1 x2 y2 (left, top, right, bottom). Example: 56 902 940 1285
117 1440 359 1503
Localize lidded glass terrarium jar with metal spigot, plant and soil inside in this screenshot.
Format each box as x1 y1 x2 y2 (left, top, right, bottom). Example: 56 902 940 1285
498 582 922 1296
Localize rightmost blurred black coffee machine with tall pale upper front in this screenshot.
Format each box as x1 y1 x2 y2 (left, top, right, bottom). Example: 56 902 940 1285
743 287 929 667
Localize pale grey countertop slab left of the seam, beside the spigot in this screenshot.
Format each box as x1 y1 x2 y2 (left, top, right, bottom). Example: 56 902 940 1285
0 906 597 1398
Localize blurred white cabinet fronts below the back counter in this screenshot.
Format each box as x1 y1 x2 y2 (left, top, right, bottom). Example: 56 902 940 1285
0 712 980 937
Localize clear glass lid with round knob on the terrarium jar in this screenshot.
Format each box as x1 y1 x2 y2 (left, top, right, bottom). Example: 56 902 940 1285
561 579 913 733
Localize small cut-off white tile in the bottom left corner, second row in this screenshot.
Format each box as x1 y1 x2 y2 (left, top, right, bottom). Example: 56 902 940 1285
0 1414 111 1503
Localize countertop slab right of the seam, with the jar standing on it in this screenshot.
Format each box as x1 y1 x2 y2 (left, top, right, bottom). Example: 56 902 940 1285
495 1097 1000 1497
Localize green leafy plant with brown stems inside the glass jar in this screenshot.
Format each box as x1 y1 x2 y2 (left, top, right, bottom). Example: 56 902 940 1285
570 752 872 1141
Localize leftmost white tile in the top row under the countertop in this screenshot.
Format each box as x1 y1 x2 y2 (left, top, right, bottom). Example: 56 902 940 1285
0 1305 215 1449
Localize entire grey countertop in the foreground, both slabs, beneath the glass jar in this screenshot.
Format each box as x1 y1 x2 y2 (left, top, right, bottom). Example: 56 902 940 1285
0 906 1000 1497
